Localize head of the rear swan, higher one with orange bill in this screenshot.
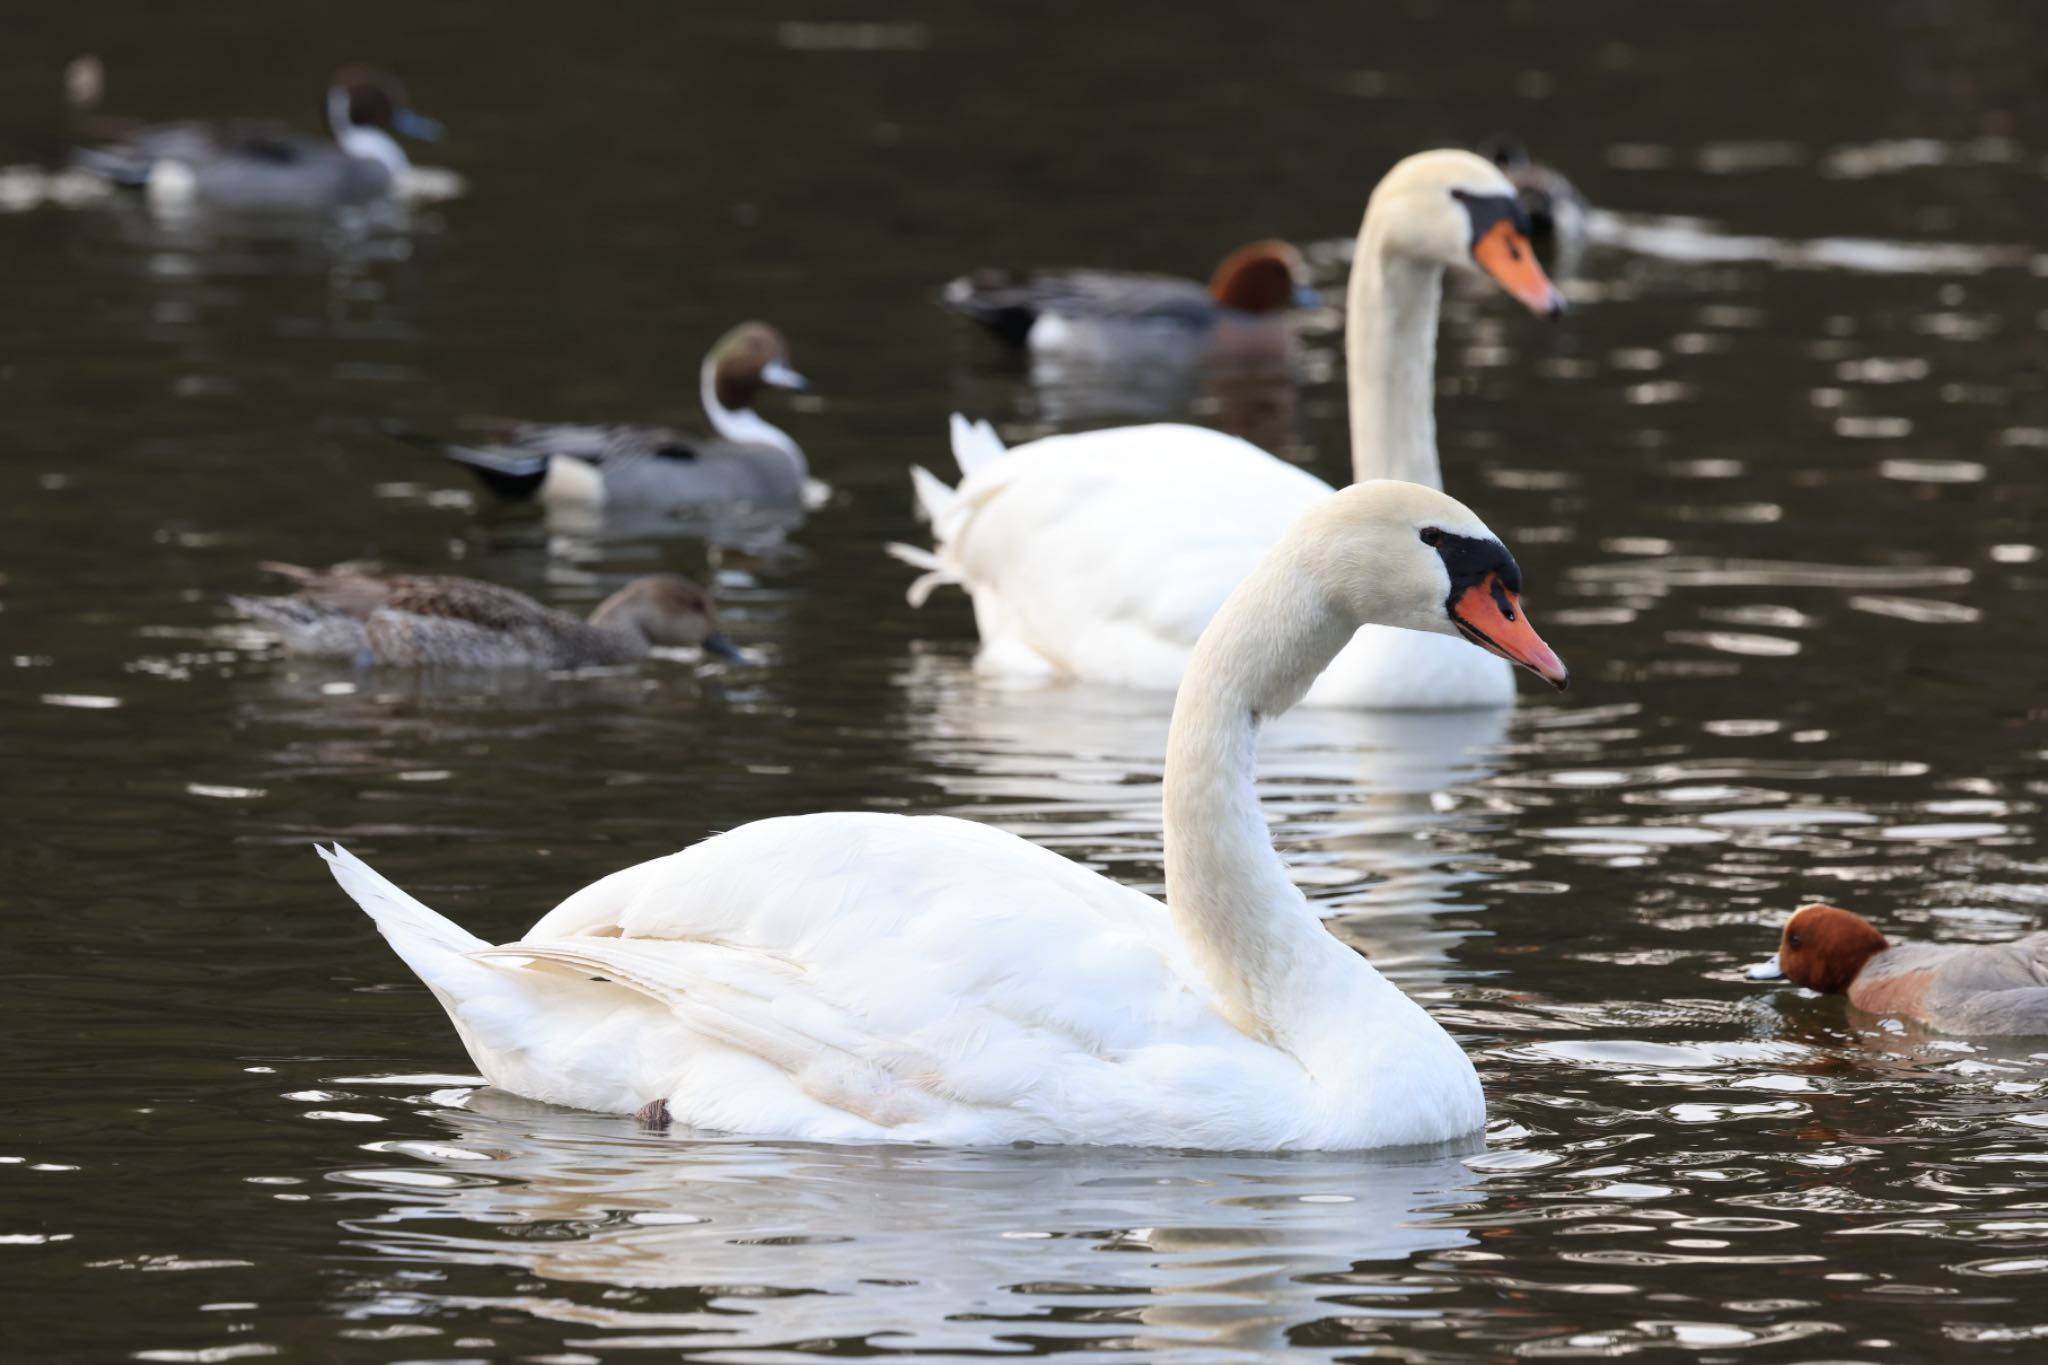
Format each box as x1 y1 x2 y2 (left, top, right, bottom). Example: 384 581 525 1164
1366 149 1565 317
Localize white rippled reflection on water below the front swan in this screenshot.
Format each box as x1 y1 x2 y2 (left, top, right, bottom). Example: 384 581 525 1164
330 1091 1477 1359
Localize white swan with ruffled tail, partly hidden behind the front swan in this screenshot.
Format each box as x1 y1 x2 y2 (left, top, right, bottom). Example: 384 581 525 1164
891 151 1565 708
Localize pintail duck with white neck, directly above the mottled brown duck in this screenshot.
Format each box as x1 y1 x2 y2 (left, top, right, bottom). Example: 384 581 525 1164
391 321 811 508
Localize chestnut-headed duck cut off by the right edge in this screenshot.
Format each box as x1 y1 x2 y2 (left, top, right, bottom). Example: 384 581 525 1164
1749 905 2048 1038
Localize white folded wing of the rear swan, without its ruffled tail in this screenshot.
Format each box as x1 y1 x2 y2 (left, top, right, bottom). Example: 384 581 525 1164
934 424 1331 688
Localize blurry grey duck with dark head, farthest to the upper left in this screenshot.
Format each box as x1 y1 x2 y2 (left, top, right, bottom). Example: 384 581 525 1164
74 65 440 211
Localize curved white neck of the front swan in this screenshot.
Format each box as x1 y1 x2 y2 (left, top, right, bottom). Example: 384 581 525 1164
1165 546 1372 1056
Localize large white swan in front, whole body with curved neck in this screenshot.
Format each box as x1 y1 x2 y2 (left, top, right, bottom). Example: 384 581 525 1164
324 481 1565 1150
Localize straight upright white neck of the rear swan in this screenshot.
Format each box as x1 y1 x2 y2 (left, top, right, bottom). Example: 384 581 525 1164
1343 229 1444 489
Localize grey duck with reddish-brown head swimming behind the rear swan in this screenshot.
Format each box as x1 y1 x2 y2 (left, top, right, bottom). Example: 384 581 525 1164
942 241 1317 360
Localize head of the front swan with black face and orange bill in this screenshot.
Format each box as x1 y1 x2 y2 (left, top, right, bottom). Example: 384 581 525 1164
1300 479 1571 690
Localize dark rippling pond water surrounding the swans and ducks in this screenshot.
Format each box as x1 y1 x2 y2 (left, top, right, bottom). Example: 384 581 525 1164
0 0 2048 1361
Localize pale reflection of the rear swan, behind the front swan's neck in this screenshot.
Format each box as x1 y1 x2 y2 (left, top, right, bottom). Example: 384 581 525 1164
899 651 1511 986
